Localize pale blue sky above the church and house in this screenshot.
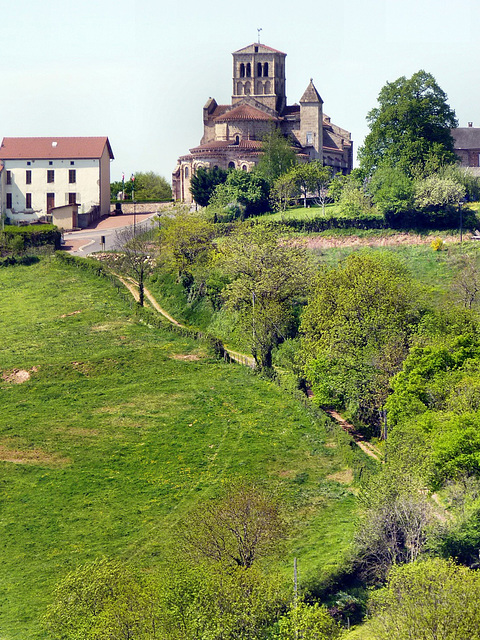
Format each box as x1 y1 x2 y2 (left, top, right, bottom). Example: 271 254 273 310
0 0 480 180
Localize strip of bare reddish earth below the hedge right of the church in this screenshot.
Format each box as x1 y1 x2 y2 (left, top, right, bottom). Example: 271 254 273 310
305 233 458 249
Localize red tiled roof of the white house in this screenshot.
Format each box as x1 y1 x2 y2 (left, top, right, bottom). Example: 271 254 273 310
0 136 113 160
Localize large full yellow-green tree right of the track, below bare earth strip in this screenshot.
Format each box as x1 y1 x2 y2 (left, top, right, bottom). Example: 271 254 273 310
300 254 418 425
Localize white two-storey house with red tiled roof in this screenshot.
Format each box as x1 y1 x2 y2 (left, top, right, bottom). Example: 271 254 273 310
0 137 113 226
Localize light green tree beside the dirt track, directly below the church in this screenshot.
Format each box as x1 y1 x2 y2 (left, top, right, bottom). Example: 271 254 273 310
220 224 312 372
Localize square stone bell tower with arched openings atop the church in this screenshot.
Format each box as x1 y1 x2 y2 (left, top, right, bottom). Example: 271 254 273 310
232 42 287 114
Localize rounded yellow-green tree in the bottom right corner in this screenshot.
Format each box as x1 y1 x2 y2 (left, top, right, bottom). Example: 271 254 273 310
368 558 480 640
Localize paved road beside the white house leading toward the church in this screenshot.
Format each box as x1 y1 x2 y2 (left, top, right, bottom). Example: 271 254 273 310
63 213 156 256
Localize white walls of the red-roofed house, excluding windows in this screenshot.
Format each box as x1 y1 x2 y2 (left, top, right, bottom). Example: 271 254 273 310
2 158 102 223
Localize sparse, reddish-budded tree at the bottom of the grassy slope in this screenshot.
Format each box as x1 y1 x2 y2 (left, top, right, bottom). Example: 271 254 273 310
181 483 286 569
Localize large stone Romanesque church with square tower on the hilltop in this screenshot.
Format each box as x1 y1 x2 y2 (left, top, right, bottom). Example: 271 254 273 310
172 42 353 203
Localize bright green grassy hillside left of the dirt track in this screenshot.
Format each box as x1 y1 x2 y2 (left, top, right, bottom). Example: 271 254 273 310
0 259 355 640
